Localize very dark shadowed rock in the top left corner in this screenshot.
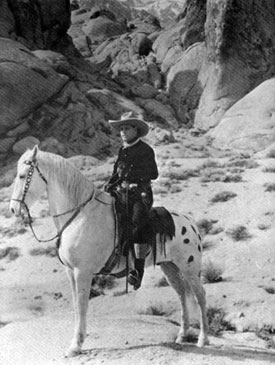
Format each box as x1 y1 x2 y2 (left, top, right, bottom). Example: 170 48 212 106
0 0 72 51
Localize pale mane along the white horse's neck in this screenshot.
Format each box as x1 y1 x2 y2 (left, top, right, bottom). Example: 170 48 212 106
37 150 95 204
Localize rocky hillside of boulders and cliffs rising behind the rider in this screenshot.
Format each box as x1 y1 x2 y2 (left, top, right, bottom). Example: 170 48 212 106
0 0 275 166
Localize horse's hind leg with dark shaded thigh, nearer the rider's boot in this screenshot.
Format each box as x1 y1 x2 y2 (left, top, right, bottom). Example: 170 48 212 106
160 262 190 343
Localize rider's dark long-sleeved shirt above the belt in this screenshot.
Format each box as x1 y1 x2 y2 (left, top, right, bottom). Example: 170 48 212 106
109 140 158 185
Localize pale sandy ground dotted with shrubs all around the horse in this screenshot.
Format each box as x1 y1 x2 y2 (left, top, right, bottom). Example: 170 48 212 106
0 132 275 365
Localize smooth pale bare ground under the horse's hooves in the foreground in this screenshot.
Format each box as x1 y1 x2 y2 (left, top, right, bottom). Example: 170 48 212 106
0 313 275 365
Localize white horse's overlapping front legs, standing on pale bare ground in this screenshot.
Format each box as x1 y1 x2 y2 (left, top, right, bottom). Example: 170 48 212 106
67 269 92 357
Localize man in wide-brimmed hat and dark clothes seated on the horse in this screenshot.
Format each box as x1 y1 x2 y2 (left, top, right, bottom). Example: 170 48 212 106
105 111 158 290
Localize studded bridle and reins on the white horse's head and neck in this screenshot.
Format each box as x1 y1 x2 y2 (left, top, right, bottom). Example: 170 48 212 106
11 159 95 248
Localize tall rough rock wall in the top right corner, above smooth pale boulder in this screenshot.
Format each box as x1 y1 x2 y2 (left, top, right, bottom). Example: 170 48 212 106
194 0 275 130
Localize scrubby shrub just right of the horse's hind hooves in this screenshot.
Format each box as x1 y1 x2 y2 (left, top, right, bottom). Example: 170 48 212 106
206 307 235 336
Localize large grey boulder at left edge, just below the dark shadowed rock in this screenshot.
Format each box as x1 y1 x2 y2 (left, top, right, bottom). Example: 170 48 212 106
0 38 68 132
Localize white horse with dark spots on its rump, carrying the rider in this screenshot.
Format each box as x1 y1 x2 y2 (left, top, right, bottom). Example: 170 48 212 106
10 146 208 356
